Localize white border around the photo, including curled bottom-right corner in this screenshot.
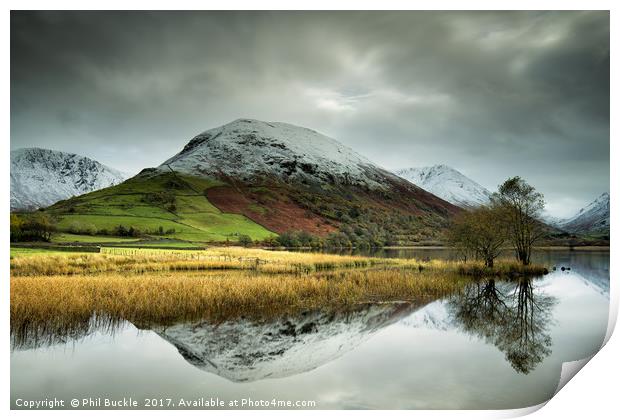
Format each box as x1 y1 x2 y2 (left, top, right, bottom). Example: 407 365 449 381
0 0 620 419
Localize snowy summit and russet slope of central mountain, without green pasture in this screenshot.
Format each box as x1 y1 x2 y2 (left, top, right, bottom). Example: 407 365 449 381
148 119 460 236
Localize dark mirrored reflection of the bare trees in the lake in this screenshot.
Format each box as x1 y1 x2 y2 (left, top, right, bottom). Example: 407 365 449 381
448 279 556 374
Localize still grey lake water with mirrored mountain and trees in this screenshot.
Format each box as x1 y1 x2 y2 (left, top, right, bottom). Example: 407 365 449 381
11 250 609 409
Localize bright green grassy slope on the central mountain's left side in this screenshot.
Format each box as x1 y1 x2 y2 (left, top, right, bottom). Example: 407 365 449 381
47 173 274 241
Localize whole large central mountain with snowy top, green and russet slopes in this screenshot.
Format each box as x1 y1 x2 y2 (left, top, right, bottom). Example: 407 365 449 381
47 119 460 246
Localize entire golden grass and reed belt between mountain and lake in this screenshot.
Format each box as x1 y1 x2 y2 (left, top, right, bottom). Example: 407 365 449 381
11 248 544 345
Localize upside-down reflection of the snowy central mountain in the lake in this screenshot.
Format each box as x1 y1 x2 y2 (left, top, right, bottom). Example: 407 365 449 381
151 304 416 382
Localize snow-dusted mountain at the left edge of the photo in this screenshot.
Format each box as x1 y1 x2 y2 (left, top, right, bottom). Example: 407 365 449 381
11 148 127 210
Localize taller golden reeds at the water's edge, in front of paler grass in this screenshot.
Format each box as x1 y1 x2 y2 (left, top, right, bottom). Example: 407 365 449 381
11 269 465 344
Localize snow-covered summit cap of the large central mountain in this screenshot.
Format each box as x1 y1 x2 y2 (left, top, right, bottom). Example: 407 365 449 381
159 119 398 189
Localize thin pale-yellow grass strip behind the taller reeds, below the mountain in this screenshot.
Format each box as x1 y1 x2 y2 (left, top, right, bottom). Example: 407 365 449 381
11 247 545 276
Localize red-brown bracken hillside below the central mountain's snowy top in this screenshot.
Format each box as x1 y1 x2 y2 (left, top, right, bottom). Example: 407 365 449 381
206 173 460 239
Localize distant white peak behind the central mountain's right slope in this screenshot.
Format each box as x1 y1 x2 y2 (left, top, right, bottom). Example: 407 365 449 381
396 165 491 207
